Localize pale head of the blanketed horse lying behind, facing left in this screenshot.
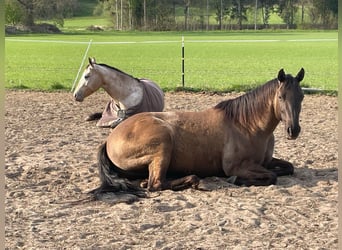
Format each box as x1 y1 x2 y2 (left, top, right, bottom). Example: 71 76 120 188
74 58 102 102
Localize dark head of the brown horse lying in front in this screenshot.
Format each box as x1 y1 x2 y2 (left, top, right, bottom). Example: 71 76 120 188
275 68 305 139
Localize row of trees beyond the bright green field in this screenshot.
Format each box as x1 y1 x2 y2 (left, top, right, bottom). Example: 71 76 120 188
5 0 338 31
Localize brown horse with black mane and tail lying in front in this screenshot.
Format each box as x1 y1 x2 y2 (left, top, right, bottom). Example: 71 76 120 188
92 68 304 196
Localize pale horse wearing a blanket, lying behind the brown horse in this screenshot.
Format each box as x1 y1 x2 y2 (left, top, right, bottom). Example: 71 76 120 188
74 58 164 127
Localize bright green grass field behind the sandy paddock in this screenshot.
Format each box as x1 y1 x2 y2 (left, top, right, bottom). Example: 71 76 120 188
5 31 338 91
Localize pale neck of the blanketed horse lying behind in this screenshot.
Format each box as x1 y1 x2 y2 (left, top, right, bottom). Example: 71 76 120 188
101 67 143 109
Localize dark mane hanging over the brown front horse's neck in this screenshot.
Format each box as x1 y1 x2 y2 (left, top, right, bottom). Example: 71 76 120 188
214 79 278 133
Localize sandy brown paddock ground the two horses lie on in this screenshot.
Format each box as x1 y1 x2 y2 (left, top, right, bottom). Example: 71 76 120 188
5 91 338 250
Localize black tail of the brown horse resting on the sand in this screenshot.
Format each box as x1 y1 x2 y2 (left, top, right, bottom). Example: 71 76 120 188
89 142 146 200
